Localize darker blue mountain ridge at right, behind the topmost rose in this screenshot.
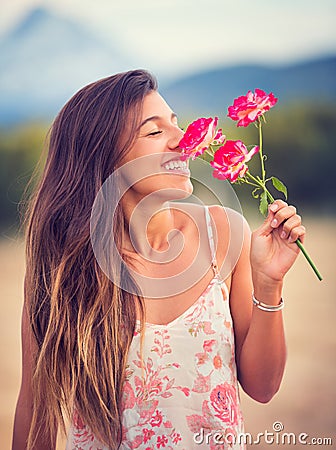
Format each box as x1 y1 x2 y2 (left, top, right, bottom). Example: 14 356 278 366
161 57 336 118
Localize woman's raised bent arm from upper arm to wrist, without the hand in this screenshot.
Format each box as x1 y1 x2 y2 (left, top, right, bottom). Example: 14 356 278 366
230 227 286 403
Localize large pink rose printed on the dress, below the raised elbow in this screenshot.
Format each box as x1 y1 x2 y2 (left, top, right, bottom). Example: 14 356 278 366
210 383 238 425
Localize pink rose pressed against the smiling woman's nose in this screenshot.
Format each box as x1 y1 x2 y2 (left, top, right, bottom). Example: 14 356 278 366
179 117 225 159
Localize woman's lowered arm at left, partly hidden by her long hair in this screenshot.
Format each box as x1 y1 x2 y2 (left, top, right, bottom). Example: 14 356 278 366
12 298 56 450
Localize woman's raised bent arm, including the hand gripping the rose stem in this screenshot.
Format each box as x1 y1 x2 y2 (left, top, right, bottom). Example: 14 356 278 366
215 200 305 403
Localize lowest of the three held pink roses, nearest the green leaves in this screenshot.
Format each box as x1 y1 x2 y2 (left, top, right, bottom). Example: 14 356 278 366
210 141 259 183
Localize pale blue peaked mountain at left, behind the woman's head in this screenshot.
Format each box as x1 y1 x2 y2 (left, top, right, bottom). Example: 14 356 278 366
0 8 132 124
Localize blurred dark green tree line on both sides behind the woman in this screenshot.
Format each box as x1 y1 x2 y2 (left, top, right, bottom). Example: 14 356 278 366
0 103 336 235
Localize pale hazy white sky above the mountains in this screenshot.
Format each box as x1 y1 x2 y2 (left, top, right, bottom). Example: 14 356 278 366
0 0 336 77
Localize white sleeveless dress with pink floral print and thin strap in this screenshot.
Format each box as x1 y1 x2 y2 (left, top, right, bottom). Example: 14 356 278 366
67 207 245 450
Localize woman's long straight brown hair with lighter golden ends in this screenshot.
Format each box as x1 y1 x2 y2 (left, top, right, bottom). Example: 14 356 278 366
25 70 157 449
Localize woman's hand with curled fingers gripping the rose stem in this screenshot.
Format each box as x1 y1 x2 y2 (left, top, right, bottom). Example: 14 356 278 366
250 200 306 282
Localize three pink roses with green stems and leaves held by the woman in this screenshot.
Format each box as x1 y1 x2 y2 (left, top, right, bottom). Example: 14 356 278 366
179 89 322 280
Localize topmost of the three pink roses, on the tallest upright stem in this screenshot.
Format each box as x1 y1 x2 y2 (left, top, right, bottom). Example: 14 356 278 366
228 89 278 127
